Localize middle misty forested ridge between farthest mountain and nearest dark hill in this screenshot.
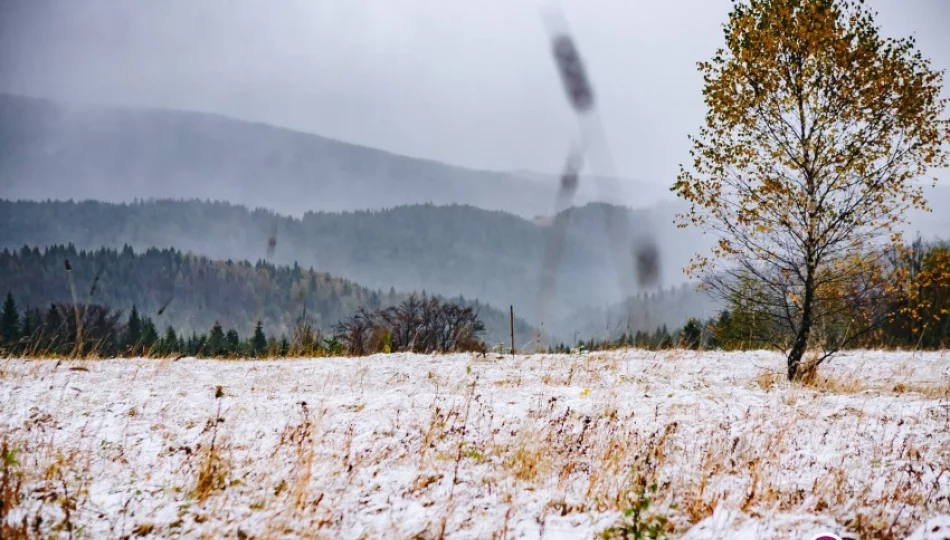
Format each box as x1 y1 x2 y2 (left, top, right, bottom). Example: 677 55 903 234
0 200 703 330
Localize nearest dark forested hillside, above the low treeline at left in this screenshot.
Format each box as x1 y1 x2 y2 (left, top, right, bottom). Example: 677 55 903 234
0 246 535 343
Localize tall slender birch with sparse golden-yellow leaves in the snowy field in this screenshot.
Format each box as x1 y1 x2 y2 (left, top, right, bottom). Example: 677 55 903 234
673 0 950 379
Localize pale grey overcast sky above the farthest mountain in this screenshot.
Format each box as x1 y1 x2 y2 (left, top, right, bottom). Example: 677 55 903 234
0 0 950 184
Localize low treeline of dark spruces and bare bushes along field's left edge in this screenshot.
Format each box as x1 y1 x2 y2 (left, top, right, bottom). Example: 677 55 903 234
0 293 485 358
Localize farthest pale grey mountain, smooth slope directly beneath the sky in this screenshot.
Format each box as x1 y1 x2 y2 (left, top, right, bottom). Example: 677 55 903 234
0 94 665 217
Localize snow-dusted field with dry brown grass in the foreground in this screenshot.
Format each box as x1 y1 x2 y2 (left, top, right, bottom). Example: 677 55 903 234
0 351 950 540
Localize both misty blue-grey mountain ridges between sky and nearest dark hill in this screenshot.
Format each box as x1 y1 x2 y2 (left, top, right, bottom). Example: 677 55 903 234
0 94 950 335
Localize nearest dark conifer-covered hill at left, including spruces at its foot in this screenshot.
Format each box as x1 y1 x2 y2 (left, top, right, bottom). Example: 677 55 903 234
0 246 533 354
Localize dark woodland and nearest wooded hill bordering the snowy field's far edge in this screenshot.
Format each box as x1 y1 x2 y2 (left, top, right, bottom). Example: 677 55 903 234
0 240 950 357
